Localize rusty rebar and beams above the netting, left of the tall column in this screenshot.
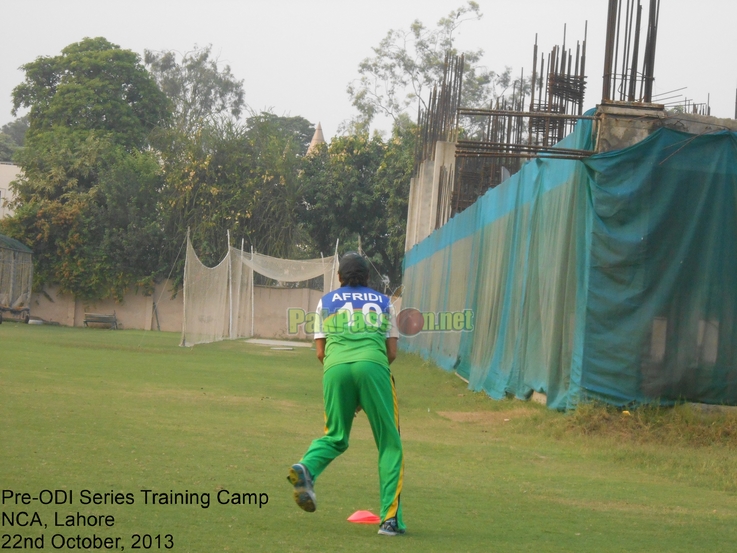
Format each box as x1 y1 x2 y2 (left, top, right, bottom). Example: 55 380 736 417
415 23 593 222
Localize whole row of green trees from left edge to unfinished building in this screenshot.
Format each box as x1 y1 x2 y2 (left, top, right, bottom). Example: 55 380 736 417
0 38 415 300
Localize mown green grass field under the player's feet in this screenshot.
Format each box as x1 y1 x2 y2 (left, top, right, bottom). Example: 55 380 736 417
0 323 737 552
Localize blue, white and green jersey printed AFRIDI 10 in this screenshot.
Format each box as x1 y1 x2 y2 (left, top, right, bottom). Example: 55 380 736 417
315 286 399 370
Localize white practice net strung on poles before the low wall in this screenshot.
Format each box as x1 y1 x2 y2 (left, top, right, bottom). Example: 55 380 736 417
181 239 338 346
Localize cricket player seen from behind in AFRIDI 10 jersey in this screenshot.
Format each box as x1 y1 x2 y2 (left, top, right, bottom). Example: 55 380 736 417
288 252 405 536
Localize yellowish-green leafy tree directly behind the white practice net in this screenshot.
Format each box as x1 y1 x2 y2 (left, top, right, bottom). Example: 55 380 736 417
161 113 314 265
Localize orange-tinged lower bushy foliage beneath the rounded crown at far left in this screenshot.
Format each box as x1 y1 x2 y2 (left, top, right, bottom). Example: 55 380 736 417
3 132 162 299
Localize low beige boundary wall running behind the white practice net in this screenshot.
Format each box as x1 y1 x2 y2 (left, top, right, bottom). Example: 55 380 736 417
31 282 322 340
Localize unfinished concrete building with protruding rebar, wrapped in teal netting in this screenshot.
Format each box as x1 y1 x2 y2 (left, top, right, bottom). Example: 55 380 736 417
401 0 737 409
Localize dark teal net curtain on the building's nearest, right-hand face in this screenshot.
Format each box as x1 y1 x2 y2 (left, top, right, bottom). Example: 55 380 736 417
581 129 737 405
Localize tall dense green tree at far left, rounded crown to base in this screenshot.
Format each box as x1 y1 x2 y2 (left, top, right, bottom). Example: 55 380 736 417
2 38 169 300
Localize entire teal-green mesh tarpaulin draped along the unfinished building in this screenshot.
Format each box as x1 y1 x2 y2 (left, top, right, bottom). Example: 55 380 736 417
400 121 737 409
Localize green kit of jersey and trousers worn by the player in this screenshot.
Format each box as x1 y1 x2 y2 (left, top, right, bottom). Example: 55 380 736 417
300 287 405 529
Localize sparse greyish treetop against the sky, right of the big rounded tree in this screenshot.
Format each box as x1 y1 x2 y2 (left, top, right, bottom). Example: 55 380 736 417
144 45 245 133
